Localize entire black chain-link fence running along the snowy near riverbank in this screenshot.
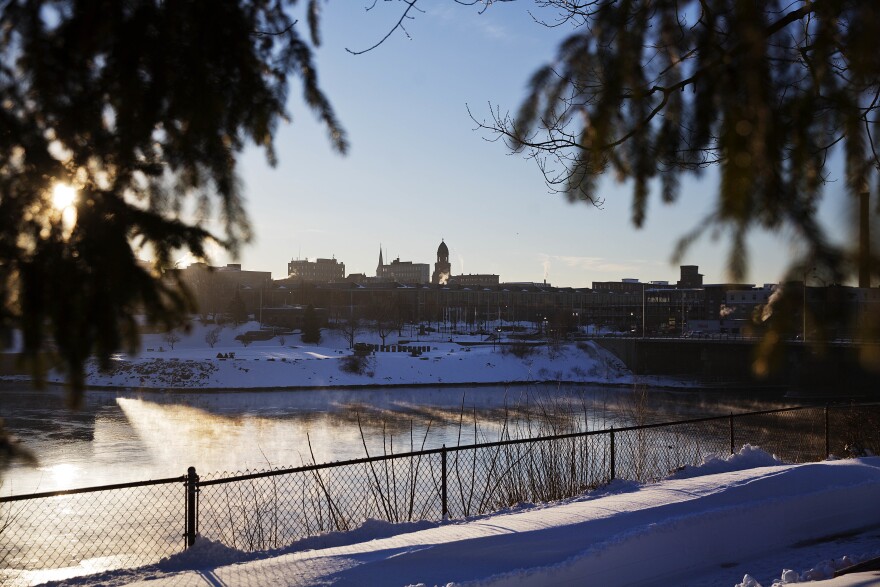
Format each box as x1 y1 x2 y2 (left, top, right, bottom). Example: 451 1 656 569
0 405 880 585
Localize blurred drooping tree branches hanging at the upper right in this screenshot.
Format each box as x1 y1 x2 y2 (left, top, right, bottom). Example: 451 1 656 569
364 0 880 354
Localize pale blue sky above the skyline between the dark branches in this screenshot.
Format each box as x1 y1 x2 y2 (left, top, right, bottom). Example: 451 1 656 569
212 0 845 287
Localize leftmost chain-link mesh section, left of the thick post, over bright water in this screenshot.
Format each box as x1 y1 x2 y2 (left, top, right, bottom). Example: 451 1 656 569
0 480 184 586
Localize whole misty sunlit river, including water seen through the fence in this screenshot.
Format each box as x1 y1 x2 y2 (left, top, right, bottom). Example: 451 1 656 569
0 385 796 587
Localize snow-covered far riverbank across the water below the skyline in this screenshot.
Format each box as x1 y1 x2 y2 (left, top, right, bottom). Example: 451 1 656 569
32 322 632 389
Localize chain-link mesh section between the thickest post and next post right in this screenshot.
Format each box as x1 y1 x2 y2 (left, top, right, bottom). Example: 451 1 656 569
199 453 441 551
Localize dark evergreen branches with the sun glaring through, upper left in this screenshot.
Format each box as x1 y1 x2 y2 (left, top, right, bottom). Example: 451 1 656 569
0 0 346 398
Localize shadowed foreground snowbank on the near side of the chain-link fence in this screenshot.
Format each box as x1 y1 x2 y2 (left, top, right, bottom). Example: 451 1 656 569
37 446 880 587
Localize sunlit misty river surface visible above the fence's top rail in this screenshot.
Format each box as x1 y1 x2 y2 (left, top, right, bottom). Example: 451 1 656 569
0 385 785 495
